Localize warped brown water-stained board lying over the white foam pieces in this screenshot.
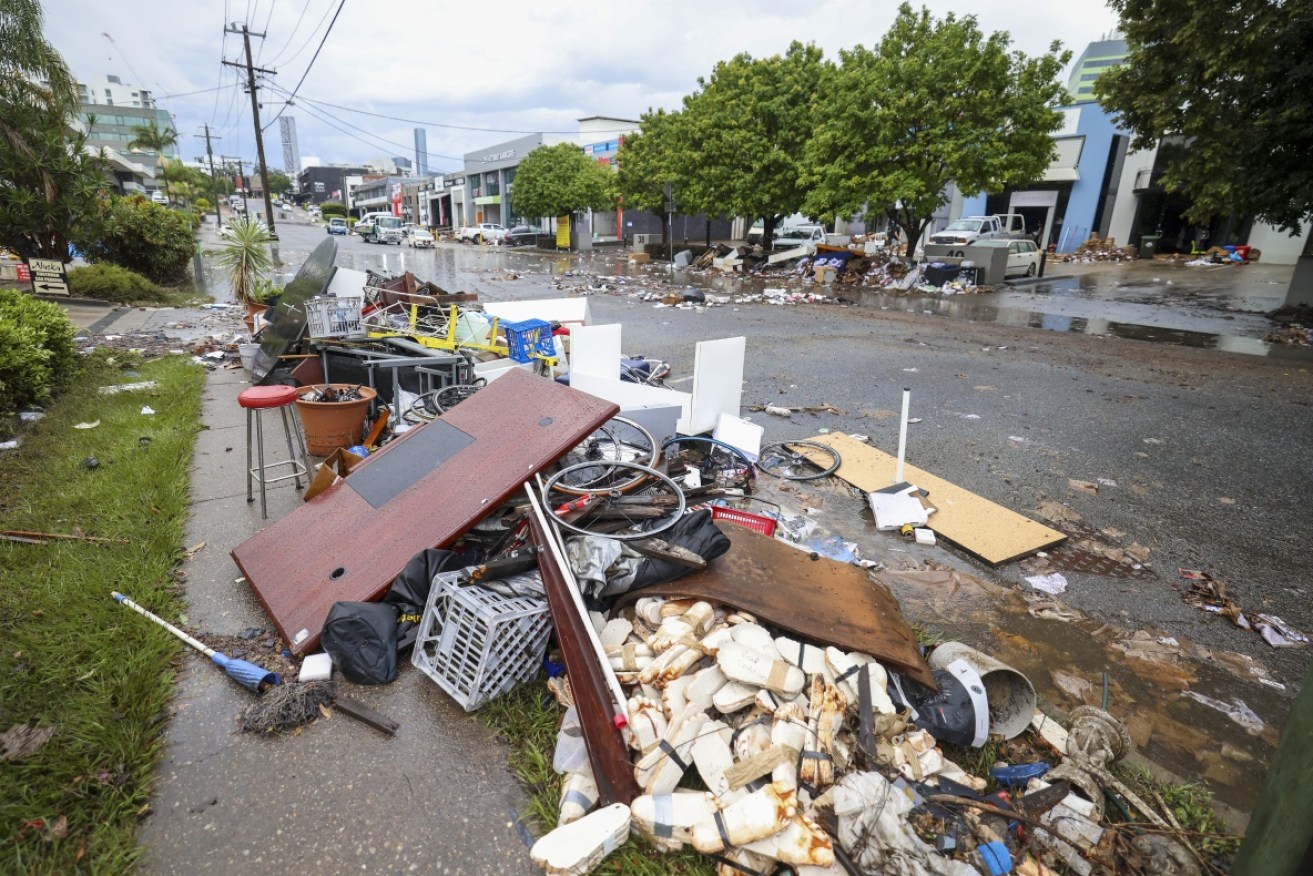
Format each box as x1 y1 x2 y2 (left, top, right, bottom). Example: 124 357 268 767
622 527 935 687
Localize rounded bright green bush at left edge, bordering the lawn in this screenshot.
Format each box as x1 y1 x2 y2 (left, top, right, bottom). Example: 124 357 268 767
0 289 77 433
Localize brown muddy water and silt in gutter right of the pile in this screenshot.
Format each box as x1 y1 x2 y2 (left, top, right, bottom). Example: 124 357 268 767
759 478 1289 812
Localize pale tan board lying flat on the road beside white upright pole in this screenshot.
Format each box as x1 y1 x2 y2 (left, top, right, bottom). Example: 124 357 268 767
809 432 1066 566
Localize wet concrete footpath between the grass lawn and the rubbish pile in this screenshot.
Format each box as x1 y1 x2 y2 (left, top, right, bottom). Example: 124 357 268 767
139 369 537 873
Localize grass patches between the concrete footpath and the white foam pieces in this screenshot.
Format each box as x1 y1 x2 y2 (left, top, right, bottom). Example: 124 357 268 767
479 678 716 876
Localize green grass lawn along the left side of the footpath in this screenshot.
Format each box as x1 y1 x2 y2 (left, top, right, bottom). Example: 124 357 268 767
0 355 205 873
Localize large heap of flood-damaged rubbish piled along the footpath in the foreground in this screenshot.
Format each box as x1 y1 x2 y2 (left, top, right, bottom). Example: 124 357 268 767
158 239 1255 876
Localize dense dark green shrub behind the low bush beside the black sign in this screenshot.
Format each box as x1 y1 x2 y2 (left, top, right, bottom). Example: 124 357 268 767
77 196 196 284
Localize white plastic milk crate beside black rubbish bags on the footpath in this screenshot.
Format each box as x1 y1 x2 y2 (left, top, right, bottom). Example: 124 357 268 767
411 571 551 712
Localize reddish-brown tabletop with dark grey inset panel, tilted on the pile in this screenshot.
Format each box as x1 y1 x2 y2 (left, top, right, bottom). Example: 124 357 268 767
232 370 618 653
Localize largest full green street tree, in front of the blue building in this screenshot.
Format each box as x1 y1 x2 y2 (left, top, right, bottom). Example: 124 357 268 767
802 3 1071 253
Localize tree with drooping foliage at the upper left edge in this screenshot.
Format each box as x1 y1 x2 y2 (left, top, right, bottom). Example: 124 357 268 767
0 0 109 260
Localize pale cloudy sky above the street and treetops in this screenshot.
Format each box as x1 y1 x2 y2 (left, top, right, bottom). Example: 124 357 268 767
43 0 1116 171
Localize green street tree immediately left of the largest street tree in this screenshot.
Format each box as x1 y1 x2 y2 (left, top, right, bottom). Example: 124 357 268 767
671 42 825 249
